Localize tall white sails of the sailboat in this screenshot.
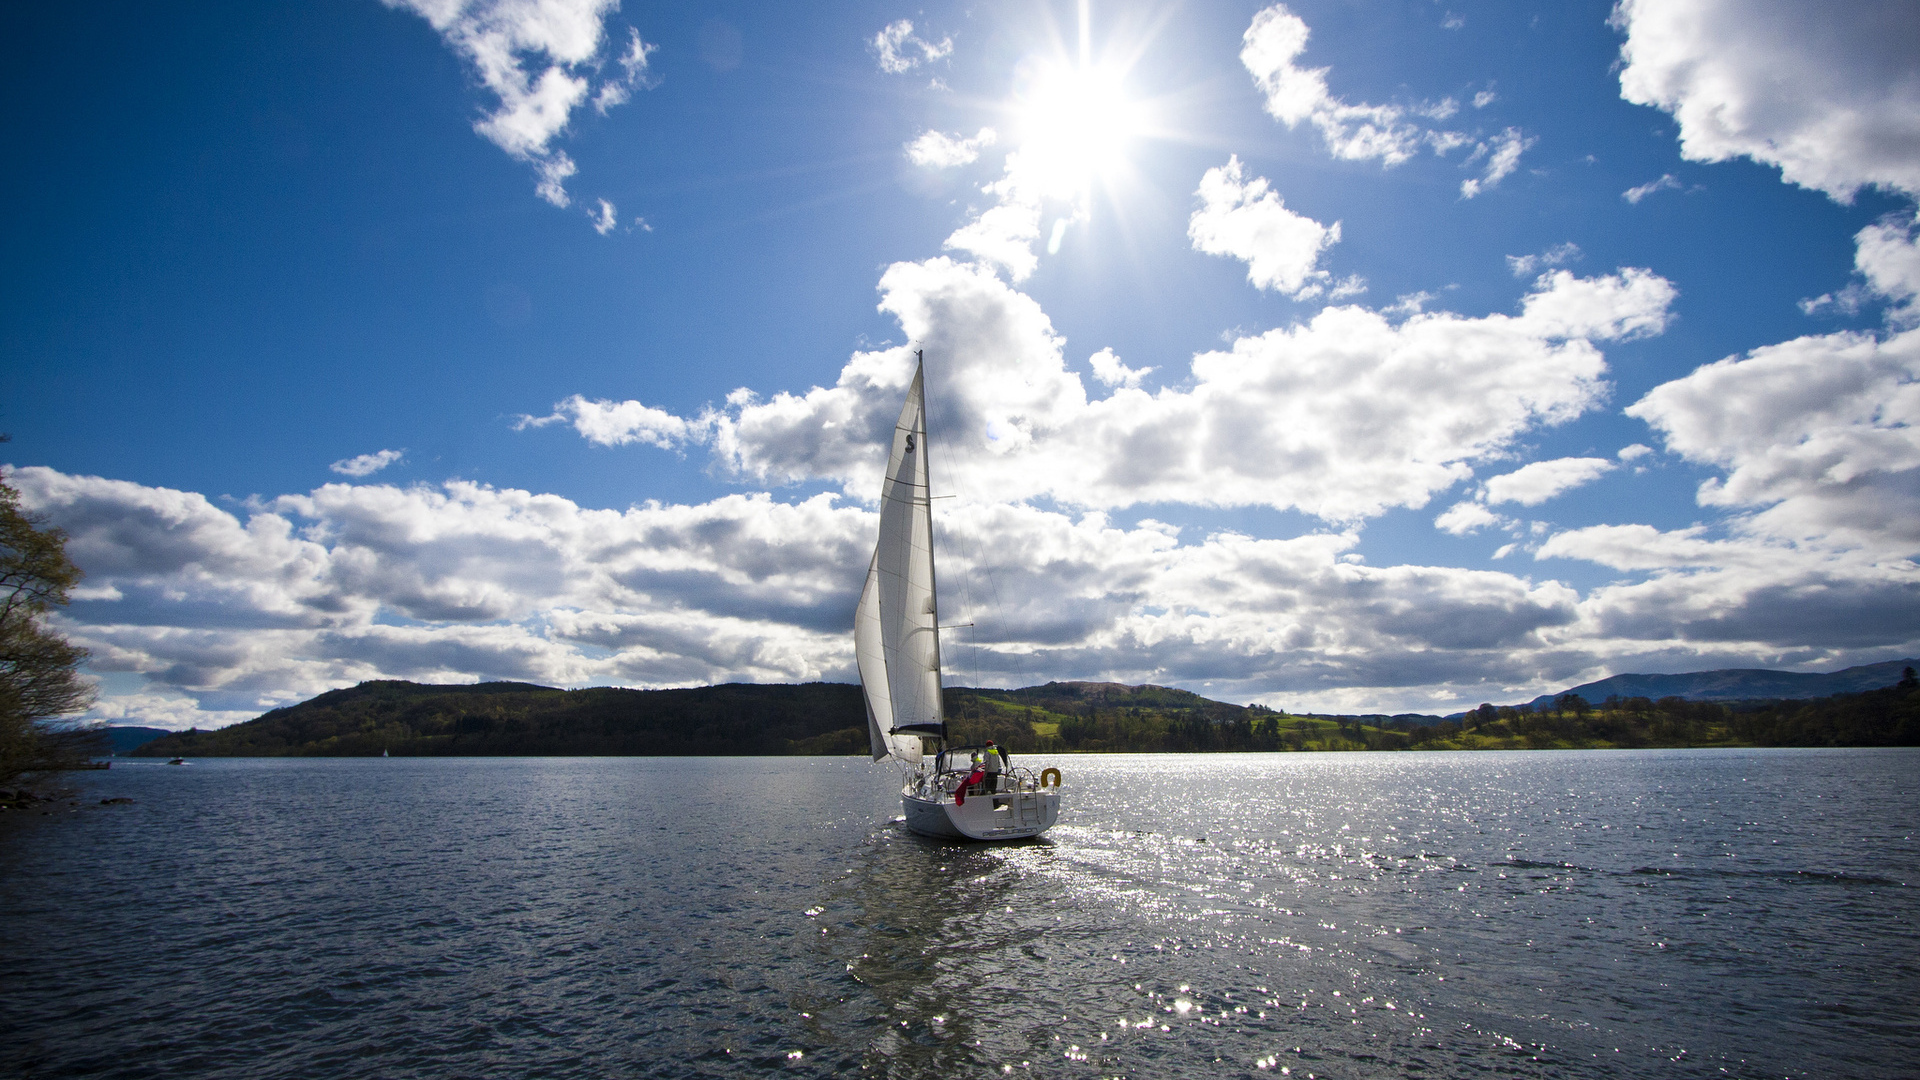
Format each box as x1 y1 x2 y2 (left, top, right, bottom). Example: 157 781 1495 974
852 357 947 761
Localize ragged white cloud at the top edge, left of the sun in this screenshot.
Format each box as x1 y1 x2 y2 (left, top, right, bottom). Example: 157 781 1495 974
382 0 655 208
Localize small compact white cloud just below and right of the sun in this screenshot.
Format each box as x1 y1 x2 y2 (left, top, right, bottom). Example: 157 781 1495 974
1187 158 1340 298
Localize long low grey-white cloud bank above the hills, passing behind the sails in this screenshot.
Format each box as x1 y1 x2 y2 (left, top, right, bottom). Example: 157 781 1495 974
13 469 1651 726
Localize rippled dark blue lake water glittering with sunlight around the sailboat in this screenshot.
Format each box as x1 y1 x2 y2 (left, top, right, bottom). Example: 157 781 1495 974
0 749 1920 1080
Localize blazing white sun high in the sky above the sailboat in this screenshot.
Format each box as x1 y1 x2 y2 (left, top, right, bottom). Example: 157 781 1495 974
1016 63 1146 198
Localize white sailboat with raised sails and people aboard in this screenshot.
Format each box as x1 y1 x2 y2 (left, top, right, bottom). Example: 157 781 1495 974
852 354 1060 840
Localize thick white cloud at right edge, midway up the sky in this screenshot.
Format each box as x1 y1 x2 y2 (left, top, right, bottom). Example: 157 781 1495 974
1626 322 1920 559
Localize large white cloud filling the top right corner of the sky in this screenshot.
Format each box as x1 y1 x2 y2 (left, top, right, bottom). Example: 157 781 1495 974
1613 0 1920 202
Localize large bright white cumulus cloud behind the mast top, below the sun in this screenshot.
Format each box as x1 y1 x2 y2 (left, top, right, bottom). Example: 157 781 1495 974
545 259 1674 521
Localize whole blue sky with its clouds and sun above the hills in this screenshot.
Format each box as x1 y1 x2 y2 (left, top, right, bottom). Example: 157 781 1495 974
0 0 1920 726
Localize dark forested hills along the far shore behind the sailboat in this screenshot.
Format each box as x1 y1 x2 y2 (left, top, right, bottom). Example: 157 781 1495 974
132 676 1920 757
